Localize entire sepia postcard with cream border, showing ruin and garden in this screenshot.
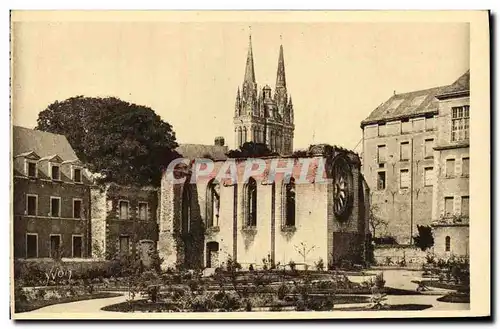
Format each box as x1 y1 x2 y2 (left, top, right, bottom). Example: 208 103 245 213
10 11 491 319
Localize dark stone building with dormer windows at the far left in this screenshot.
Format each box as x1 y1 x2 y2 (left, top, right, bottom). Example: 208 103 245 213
12 126 92 258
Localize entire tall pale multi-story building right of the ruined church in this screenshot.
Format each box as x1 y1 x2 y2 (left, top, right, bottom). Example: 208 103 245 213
361 71 469 256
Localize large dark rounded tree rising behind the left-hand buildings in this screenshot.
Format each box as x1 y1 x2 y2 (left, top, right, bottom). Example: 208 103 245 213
36 96 178 186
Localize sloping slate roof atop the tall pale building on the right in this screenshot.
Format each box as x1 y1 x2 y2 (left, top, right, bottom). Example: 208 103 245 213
361 71 469 128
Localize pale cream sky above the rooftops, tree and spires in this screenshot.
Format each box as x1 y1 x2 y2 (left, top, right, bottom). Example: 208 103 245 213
12 20 469 152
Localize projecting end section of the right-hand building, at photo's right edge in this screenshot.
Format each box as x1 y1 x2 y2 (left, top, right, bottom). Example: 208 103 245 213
432 71 470 257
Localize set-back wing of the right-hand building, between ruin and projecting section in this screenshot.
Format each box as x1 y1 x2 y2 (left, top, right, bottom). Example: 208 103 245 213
361 88 442 244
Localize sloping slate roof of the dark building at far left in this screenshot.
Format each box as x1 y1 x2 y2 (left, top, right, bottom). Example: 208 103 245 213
12 126 78 160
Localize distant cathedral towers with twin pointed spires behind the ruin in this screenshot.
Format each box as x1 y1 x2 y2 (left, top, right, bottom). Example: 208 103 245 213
234 37 295 154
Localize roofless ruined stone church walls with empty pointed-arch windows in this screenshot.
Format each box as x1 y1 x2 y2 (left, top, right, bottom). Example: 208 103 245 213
159 146 368 268
